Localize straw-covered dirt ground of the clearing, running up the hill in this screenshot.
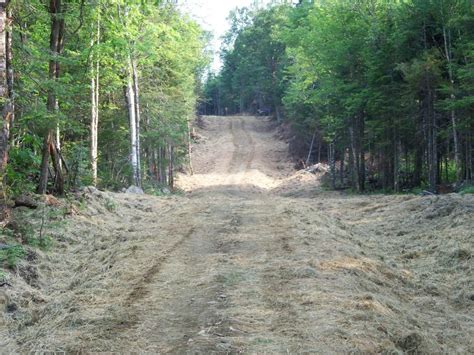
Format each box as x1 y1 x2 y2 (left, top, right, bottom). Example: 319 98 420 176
0 117 474 354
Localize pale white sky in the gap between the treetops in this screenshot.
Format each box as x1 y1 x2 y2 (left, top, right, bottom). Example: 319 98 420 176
178 0 269 71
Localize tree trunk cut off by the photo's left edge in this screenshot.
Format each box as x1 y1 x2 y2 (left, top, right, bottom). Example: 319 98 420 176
0 1 14 200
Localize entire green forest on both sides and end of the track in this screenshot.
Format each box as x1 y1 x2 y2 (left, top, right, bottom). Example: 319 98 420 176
0 0 474 196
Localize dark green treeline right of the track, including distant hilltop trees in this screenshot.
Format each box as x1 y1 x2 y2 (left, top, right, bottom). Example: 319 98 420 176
206 0 474 192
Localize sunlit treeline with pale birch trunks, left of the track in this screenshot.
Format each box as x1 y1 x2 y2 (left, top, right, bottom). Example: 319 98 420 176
0 0 208 194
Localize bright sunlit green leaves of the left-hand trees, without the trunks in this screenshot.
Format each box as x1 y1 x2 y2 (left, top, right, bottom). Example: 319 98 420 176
7 0 209 195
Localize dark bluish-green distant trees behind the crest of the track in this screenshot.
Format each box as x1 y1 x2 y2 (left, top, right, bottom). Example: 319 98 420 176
201 5 290 115
